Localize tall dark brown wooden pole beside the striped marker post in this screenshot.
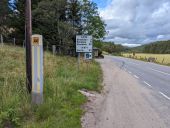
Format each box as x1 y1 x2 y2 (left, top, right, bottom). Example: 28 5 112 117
25 0 32 93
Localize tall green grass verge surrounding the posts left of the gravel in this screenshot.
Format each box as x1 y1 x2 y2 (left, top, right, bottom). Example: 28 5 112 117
0 46 102 128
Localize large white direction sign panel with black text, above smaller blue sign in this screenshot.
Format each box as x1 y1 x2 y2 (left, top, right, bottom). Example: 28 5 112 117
76 35 93 53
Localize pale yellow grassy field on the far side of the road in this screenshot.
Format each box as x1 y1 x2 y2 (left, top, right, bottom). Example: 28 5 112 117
122 53 170 66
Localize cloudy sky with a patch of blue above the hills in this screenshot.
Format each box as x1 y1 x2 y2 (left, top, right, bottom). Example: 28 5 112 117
93 0 170 47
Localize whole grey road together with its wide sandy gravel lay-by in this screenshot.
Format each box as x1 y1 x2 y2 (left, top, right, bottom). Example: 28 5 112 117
82 56 170 128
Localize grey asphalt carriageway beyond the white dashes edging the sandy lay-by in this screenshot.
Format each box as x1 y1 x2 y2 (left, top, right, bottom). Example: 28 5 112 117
107 57 170 99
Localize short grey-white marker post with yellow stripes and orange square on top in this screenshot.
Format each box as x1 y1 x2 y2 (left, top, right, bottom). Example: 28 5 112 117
31 34 43 104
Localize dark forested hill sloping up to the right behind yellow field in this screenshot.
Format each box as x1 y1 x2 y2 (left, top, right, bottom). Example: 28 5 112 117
130 40 170 54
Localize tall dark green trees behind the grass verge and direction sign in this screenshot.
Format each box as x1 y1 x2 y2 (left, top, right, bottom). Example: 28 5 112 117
0 0 106 53
